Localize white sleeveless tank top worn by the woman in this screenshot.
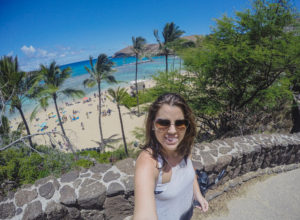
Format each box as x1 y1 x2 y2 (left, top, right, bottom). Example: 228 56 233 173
154 156 195 220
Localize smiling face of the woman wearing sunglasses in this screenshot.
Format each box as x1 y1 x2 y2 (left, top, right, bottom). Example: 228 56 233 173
153 104 186 153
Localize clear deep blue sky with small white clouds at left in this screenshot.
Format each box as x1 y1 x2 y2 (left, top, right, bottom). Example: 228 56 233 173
0 0 300 71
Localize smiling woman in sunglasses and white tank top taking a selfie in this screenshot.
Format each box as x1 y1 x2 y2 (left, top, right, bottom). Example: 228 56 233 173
133 93 208 220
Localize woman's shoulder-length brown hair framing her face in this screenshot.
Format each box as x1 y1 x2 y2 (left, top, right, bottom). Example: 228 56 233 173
142 93 196 165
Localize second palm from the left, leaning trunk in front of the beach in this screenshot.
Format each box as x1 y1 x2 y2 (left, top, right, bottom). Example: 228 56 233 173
38 61 84 144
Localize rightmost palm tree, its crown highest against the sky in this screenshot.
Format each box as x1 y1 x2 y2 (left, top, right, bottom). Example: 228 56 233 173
154 22 185 72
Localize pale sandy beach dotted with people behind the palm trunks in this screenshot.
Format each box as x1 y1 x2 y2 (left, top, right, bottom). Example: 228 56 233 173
12 80 154 150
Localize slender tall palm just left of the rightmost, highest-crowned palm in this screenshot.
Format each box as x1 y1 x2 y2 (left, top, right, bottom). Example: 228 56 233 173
132 37 146 115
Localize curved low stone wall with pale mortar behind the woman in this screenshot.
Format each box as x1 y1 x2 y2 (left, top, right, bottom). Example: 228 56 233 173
0 133 300 220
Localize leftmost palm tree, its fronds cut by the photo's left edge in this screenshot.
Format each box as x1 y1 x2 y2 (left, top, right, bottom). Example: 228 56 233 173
0 56 37 148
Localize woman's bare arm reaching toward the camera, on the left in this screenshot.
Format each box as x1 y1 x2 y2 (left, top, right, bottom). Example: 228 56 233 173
133 151 158 220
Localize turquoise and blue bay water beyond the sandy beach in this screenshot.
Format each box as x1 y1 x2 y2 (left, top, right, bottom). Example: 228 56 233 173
8 56 179 118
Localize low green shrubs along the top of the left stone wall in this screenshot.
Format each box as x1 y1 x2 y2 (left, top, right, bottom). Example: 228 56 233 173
0 146 134 194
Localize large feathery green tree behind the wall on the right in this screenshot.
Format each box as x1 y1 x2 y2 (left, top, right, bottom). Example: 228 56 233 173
183 0 300 137
